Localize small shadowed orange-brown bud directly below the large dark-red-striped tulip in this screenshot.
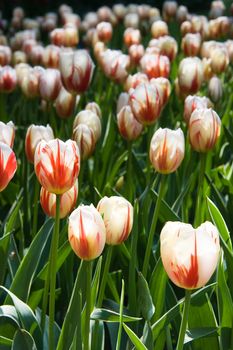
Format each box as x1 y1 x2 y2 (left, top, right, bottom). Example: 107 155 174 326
55 86 76 118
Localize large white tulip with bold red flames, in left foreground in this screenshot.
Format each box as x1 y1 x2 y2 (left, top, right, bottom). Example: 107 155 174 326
34 139 80 194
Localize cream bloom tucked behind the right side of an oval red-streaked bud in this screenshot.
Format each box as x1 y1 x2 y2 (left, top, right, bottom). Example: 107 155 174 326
97 196 133 245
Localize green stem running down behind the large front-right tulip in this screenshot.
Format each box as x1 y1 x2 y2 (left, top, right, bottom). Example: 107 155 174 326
194 153 206 227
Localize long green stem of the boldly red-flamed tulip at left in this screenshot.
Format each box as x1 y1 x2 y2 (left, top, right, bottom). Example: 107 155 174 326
49 194 61 350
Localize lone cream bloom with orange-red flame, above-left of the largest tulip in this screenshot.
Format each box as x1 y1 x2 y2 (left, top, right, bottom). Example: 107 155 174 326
150 128 185 174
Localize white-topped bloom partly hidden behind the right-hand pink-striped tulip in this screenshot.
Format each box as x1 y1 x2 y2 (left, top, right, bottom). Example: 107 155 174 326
184 95 211 124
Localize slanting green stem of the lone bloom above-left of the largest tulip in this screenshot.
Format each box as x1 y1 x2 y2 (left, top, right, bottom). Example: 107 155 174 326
142 175 166 278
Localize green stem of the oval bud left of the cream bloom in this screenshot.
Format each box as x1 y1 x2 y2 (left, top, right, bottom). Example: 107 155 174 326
83 261 92 350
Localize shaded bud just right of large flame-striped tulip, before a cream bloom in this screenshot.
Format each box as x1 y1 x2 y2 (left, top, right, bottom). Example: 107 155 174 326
73 124 96 159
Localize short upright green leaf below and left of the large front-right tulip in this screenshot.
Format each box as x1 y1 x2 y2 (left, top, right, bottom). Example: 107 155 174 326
138 272 155 321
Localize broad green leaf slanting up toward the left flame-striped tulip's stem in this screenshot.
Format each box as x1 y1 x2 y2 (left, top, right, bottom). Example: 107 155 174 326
10 219 53 301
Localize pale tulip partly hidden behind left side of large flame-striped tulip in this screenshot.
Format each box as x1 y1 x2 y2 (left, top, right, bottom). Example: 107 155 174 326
25 124 54 163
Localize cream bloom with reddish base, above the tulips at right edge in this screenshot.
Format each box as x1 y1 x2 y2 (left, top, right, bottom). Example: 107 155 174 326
178 57 203 94
